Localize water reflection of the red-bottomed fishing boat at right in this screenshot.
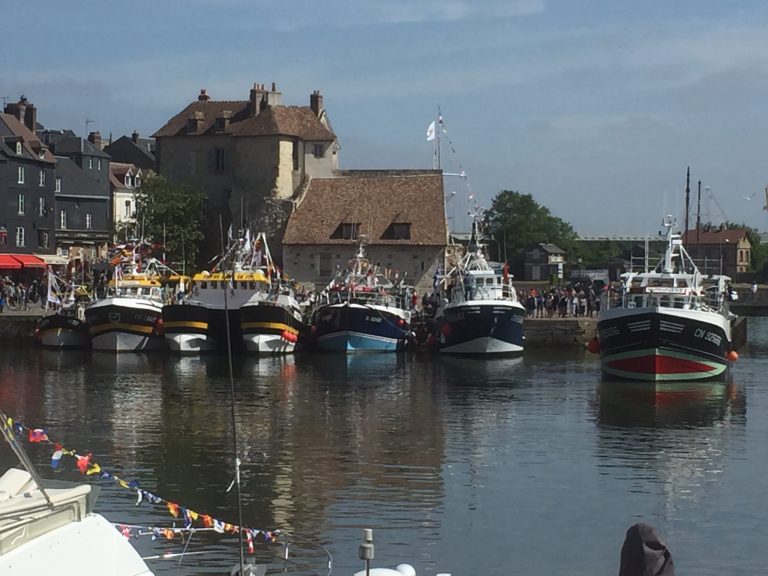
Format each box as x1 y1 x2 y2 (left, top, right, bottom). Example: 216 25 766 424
597 379 745 521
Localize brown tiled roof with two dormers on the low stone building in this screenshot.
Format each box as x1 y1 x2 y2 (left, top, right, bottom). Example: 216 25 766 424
283 170 447 246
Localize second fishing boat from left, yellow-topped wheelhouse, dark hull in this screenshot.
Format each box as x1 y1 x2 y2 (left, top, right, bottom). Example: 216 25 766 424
85 258 166 352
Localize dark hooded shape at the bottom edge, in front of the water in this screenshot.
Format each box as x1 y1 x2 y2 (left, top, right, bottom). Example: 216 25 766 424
619 524 675 576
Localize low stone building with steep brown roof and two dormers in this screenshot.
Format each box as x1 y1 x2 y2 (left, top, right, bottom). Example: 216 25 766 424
283 170 448 294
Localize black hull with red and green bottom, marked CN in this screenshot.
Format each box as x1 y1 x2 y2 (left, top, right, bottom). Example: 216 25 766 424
597 308 731 382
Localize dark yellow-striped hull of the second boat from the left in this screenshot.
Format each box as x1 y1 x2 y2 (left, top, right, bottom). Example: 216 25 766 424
85 298 166 352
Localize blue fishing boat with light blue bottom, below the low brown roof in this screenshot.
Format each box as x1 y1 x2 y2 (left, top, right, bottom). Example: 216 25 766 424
310 239 411 352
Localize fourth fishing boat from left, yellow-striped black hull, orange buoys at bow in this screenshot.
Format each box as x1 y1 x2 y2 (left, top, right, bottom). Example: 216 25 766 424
239 232 306 354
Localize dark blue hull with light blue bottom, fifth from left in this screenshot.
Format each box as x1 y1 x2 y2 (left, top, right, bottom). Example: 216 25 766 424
313 303 410 352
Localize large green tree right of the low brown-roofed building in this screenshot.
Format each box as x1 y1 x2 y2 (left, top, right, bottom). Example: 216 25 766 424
485 190 577 260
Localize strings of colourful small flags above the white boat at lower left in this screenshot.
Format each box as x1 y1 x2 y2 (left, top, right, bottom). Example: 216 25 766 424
5 417 281 554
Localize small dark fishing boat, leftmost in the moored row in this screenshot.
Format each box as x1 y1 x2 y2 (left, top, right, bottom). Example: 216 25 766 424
35 268 91 348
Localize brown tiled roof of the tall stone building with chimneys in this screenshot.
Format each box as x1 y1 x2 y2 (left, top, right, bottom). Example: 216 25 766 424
153 100 336 141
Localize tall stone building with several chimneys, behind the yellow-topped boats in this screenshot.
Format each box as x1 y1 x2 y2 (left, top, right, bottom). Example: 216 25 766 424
153 83 339 261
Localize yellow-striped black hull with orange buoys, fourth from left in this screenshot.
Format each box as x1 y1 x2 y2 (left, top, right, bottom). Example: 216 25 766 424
240 301 304 354
